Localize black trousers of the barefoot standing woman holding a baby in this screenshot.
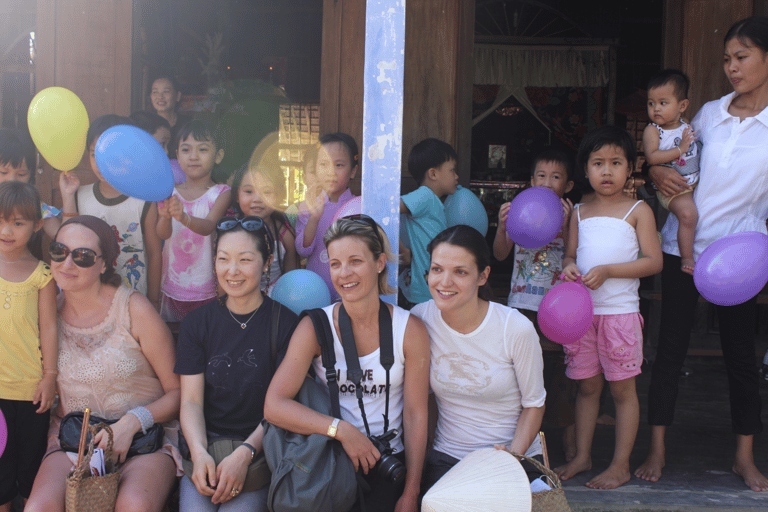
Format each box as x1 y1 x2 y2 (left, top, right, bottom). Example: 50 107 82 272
648 253 763 435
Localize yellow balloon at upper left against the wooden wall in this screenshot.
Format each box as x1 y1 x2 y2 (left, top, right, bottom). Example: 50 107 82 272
27 87 89 172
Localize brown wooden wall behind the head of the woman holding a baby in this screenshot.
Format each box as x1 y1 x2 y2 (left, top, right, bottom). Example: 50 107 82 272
663 0 752 118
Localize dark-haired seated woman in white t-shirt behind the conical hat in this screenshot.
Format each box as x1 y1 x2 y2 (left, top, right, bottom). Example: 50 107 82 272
411 225 546 491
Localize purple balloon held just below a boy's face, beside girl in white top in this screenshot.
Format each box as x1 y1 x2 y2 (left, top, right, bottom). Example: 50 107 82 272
507 187 563 249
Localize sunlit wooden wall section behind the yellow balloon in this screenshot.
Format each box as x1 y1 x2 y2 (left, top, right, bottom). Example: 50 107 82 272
35 0 133 205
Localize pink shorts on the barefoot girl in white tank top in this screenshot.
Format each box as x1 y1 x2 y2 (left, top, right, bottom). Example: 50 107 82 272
563 313 643 381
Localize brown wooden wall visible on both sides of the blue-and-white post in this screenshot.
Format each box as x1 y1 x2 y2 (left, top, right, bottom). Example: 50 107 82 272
320 0 474 193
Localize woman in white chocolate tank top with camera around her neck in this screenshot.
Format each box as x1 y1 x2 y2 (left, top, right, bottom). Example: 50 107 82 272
264 216 429 511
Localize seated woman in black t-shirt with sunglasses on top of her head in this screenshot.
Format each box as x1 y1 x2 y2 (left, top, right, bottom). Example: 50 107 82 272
175 216 297 512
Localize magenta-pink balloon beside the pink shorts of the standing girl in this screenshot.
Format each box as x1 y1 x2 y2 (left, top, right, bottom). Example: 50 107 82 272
538 283 595 345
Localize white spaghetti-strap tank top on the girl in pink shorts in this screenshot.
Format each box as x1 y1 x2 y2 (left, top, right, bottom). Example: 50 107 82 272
576 201 642 315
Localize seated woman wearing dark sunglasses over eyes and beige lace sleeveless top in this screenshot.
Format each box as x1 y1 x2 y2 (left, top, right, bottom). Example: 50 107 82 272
25 215 181 512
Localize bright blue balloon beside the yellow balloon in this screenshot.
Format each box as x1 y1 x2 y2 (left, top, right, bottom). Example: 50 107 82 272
94 124 174 201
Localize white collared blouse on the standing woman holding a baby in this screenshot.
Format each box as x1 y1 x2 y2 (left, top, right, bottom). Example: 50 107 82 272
661 92 768 258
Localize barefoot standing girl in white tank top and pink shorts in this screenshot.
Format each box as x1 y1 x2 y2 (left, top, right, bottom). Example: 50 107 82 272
555 126 662 489
